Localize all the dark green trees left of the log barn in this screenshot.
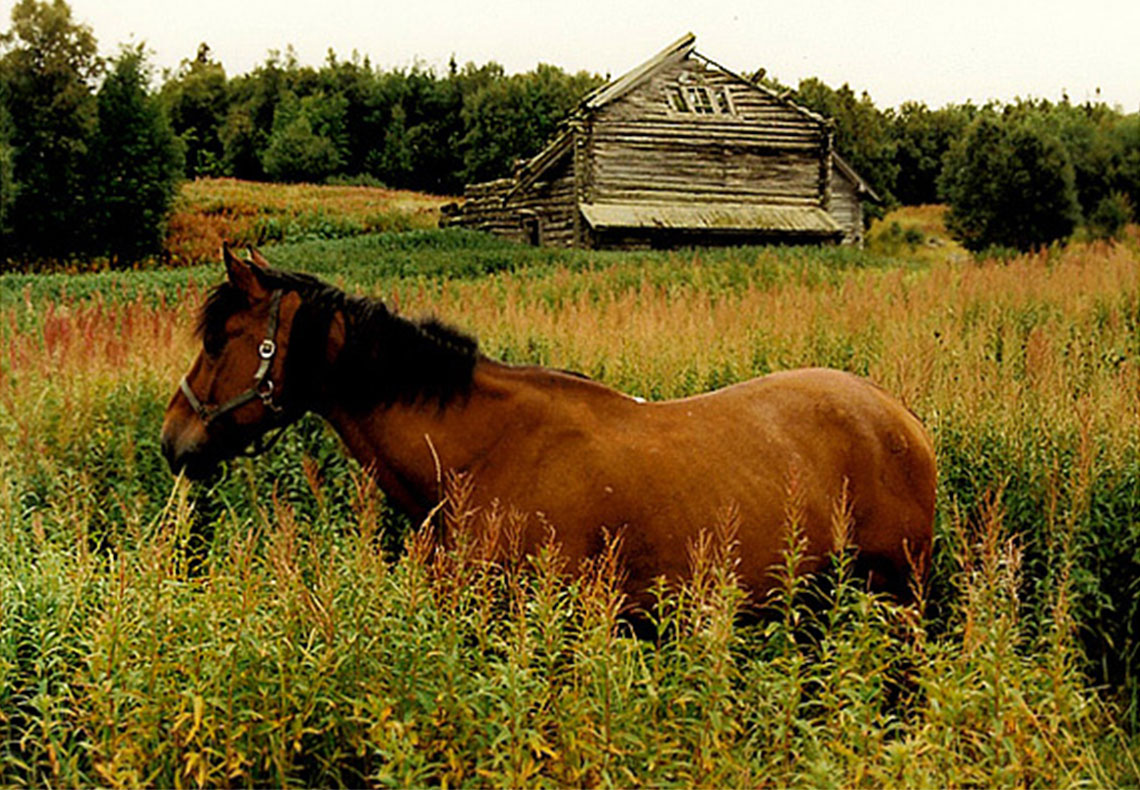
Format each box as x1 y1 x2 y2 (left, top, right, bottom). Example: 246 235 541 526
0 0 604 263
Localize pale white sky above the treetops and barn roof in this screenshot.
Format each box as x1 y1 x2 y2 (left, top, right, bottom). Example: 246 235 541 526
0 0 1140 112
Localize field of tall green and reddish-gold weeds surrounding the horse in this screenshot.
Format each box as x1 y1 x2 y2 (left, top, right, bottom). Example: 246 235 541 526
0 212 1140 788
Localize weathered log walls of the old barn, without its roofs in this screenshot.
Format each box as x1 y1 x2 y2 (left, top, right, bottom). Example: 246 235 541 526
440 50 863 247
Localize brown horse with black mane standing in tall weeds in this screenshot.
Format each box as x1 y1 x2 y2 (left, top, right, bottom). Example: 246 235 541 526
162 250 935 602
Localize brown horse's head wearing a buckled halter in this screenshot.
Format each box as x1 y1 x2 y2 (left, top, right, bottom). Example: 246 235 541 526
162 247 301 478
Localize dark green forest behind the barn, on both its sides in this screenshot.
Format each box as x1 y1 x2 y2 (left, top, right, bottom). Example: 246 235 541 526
0 0 1140 262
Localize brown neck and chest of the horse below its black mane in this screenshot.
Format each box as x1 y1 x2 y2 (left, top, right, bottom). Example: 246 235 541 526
324 360 528 515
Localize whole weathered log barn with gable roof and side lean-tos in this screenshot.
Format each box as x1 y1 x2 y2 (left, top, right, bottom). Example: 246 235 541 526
440 34 873 249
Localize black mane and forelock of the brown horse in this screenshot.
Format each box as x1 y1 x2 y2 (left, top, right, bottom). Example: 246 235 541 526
197 269 479 412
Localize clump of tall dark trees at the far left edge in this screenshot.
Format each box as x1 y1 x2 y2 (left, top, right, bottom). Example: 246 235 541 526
0 0 182 261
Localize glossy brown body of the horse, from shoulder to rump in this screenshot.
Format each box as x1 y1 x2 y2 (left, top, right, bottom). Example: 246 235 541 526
481 368 935 597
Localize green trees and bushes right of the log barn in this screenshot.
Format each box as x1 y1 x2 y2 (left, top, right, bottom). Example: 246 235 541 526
779 74 1140 251
